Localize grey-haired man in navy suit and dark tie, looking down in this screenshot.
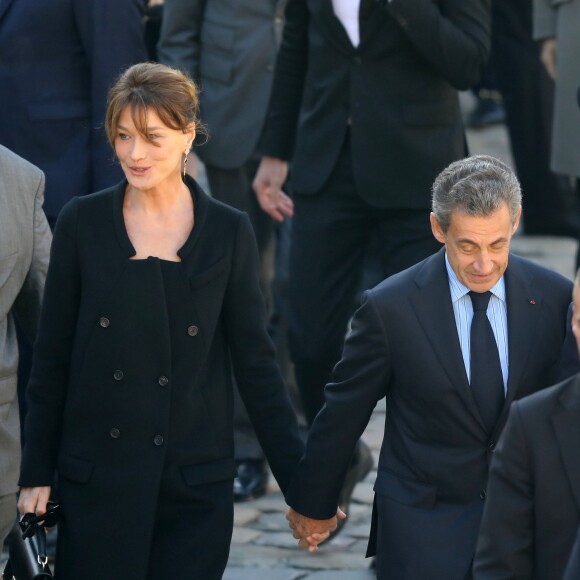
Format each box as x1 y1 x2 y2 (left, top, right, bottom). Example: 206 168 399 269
286 156 572 580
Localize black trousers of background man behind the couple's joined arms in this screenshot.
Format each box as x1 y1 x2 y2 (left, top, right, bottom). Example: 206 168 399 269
288 132 440 424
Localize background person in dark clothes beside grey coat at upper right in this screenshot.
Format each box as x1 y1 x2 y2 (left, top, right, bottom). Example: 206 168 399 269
490 0 580 238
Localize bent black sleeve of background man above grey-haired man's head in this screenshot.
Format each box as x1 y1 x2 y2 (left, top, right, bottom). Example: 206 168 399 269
378 0 491 90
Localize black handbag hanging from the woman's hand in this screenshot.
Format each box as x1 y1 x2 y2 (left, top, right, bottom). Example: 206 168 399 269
2 504 60 580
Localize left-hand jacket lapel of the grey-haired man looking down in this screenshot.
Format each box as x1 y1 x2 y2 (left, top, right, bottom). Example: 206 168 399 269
411 248 485 430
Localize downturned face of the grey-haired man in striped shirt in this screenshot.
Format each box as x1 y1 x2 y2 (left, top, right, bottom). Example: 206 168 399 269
431 203 521 292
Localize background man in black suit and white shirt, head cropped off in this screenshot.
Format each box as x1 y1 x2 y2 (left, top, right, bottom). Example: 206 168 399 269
254 0 489 498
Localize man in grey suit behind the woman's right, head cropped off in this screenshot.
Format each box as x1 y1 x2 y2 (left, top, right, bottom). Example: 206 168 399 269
158 0 286 500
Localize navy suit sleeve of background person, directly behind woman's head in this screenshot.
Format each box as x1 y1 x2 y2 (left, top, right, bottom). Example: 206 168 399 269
73 0 147 194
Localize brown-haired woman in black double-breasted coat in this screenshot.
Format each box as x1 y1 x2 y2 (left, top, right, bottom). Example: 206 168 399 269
19 63 302 580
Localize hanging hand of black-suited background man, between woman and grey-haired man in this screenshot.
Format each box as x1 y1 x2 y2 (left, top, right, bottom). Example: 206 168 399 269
253 157 294 222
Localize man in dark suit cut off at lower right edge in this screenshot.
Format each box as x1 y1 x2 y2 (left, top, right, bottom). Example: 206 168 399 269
474 270 580 580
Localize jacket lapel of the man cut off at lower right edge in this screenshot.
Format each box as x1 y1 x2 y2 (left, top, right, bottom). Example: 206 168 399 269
551 377 580 509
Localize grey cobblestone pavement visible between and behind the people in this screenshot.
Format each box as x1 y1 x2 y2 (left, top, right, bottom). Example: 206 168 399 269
0 94 576 580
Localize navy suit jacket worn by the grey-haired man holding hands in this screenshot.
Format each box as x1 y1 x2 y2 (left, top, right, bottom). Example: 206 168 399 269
286 249 572 580
